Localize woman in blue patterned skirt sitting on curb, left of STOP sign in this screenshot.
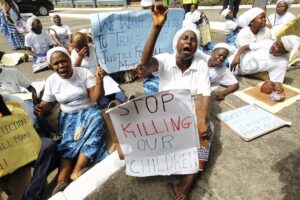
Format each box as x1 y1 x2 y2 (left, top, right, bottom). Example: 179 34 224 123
35 47 107 193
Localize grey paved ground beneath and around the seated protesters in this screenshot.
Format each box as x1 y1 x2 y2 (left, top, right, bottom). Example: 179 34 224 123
0 4 300 200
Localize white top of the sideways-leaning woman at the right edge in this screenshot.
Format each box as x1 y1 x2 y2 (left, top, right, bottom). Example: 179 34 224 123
230 40 288 83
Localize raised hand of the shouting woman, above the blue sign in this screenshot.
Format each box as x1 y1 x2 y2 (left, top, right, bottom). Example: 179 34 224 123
151 4 168 27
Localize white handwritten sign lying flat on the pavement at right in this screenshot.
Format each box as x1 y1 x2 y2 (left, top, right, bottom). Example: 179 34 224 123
218 105 291 141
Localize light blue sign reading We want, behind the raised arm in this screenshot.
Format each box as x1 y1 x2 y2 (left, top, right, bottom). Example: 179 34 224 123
91 9 184 73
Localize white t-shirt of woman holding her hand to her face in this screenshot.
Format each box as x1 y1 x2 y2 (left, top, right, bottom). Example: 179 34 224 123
71 45 97 75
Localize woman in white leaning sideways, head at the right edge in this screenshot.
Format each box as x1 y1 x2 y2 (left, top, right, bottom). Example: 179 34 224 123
230 35 300 101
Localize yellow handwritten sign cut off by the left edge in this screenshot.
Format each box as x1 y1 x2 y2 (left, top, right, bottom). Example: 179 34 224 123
0 102 41 177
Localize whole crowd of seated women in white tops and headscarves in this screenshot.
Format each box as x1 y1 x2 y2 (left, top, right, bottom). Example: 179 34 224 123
0 0 300 199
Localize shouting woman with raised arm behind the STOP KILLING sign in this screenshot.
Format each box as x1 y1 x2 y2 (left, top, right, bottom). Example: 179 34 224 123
141 5 212 199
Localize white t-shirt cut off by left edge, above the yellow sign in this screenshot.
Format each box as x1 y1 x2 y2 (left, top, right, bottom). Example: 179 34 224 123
0 68 31 94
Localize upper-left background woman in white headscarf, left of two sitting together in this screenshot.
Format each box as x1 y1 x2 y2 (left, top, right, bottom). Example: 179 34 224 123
25 16 55 62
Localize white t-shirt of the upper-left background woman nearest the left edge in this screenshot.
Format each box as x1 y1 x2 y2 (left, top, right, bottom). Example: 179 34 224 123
25 31 55 54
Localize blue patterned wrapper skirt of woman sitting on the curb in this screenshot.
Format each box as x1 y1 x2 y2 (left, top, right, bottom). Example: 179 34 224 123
58 106 108 164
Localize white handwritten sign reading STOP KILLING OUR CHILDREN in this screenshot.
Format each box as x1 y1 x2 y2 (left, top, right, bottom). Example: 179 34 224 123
108 90 199 177
